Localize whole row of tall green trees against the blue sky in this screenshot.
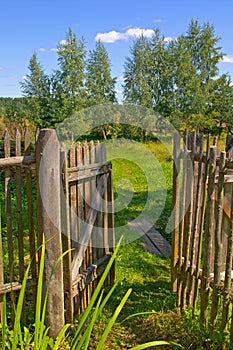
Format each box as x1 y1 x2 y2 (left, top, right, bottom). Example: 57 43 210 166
0 20 233 134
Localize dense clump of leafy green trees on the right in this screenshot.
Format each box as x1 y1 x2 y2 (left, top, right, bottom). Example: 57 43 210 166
124 20 233 134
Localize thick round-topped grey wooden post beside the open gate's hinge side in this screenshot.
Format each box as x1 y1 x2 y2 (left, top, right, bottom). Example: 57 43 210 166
36 129 64 338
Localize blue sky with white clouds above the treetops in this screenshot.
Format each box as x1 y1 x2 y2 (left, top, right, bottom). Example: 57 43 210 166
0 0 233 99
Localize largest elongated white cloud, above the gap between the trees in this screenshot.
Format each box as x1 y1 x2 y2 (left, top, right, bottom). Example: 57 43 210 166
95 28 154 43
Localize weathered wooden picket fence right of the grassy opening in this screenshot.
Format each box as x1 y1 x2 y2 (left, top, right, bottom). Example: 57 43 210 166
171 132 233 344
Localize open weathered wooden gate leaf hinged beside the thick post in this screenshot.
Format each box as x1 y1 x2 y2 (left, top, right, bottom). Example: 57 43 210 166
58 131 115 322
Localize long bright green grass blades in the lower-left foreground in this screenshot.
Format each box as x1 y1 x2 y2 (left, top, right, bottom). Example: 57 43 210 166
1 234 178 350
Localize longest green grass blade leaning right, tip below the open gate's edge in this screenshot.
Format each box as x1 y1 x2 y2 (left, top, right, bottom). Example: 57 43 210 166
71 236 123 350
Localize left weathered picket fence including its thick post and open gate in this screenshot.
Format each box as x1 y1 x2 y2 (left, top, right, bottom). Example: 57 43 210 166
0 129 114 337
